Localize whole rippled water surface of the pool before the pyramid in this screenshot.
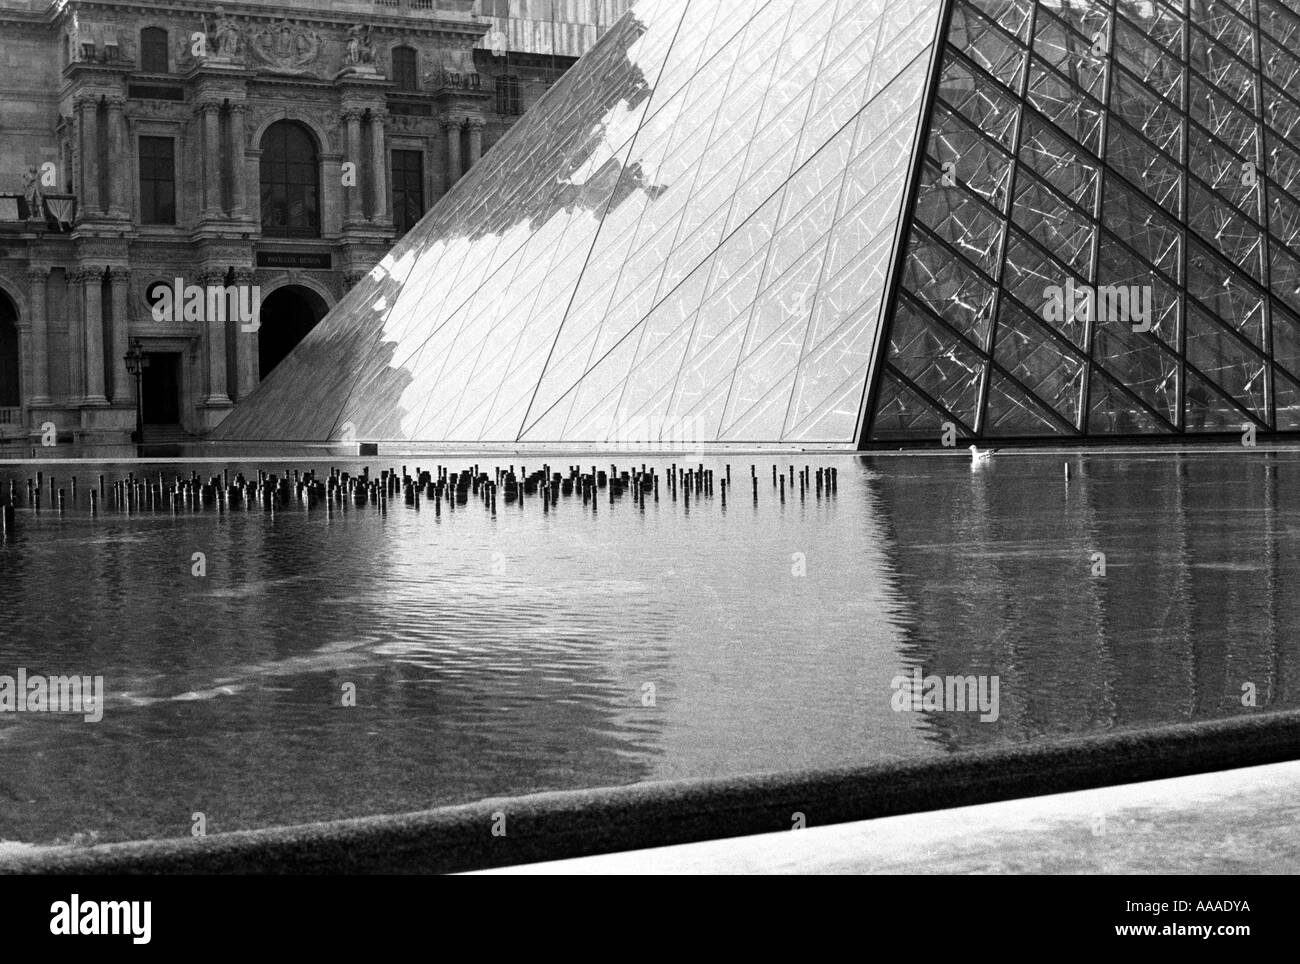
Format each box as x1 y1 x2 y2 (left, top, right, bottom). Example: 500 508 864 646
0 453 1300 842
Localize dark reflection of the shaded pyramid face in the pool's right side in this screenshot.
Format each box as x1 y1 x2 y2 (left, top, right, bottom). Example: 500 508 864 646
874 453 1300 748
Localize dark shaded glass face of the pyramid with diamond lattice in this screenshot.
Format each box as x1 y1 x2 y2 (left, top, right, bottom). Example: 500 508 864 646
863 0 1300 446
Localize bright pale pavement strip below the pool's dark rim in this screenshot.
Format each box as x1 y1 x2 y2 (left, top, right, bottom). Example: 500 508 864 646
475 763 1300 874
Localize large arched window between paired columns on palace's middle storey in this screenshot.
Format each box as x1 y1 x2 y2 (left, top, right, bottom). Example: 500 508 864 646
261 121 321 238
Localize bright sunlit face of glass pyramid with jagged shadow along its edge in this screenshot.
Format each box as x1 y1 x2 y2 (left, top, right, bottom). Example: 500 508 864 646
217 0 940 444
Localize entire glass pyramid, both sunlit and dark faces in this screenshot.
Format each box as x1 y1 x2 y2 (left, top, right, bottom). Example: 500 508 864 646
217 0 1300 448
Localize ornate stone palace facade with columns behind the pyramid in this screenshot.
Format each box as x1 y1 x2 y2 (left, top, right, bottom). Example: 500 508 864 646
0 0 628 456
